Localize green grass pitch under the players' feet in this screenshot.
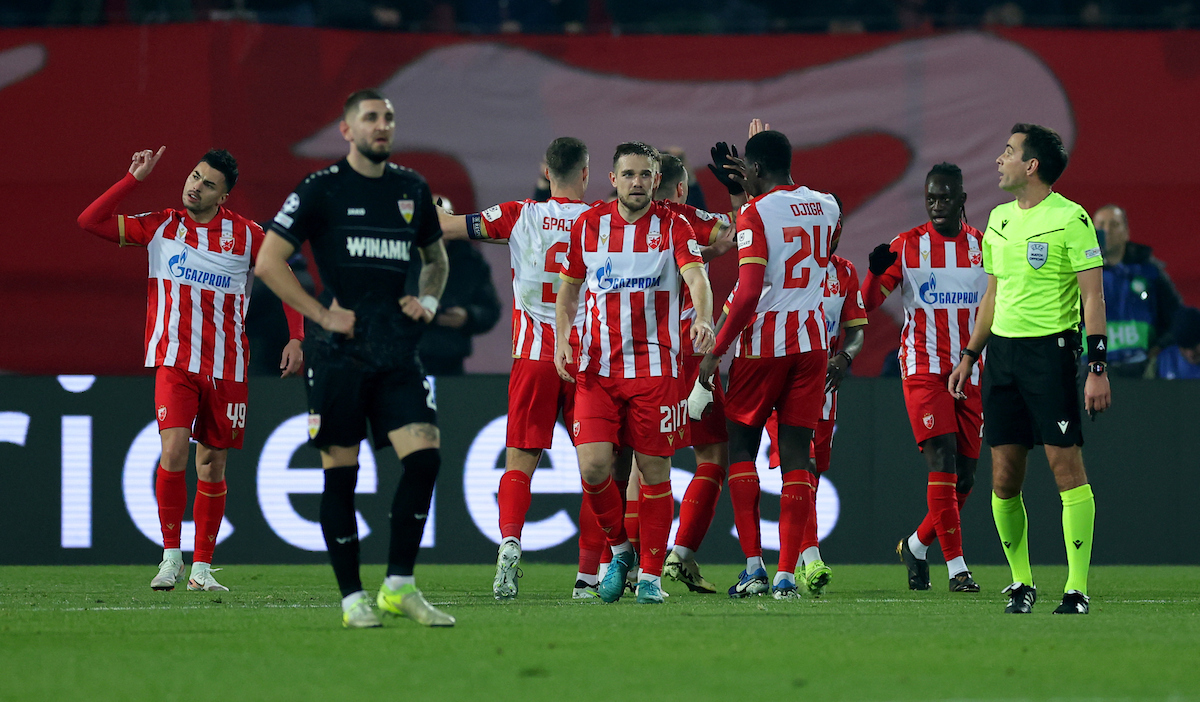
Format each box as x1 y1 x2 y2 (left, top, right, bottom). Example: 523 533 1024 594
0 564 1200 702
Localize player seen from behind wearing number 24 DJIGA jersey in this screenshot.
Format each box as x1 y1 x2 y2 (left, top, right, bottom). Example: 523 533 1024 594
700 130 841 598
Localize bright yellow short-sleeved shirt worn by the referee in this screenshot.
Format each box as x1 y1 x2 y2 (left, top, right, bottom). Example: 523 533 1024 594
983 192 1104 338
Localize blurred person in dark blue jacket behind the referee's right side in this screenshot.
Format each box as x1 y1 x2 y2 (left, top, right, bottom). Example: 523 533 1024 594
1092 205 1180 378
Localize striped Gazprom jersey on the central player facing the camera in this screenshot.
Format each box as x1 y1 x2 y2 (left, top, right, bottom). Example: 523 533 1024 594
560 200 703 378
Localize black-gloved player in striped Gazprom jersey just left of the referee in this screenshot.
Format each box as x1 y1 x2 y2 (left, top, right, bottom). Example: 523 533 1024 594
863 163 988 593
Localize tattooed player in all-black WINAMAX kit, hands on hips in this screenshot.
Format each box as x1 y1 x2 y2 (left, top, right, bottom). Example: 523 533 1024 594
260 90 455 629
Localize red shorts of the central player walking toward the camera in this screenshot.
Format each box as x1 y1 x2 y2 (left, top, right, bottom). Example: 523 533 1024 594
571 372 689 456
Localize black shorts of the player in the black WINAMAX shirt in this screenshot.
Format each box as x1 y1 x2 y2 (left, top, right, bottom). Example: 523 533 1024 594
305 359 438 449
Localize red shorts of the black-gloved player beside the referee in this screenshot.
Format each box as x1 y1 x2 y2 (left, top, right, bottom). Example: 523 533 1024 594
904 373 983 458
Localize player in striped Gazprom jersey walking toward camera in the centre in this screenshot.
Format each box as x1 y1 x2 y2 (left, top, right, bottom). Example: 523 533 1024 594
554 142 713 604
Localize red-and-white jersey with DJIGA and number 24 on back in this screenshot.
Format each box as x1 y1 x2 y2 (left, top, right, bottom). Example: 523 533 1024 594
737 185 841 358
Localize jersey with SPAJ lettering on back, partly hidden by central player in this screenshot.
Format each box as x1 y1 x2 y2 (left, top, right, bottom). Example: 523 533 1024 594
480 198 592 361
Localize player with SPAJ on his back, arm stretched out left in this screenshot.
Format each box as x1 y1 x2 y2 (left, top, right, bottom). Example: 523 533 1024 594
439 137 605 600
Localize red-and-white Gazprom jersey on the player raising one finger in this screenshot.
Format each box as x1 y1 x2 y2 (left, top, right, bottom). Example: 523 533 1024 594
118 208 263 383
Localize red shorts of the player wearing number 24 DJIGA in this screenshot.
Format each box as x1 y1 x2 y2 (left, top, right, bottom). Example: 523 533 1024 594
725 349 829 428
